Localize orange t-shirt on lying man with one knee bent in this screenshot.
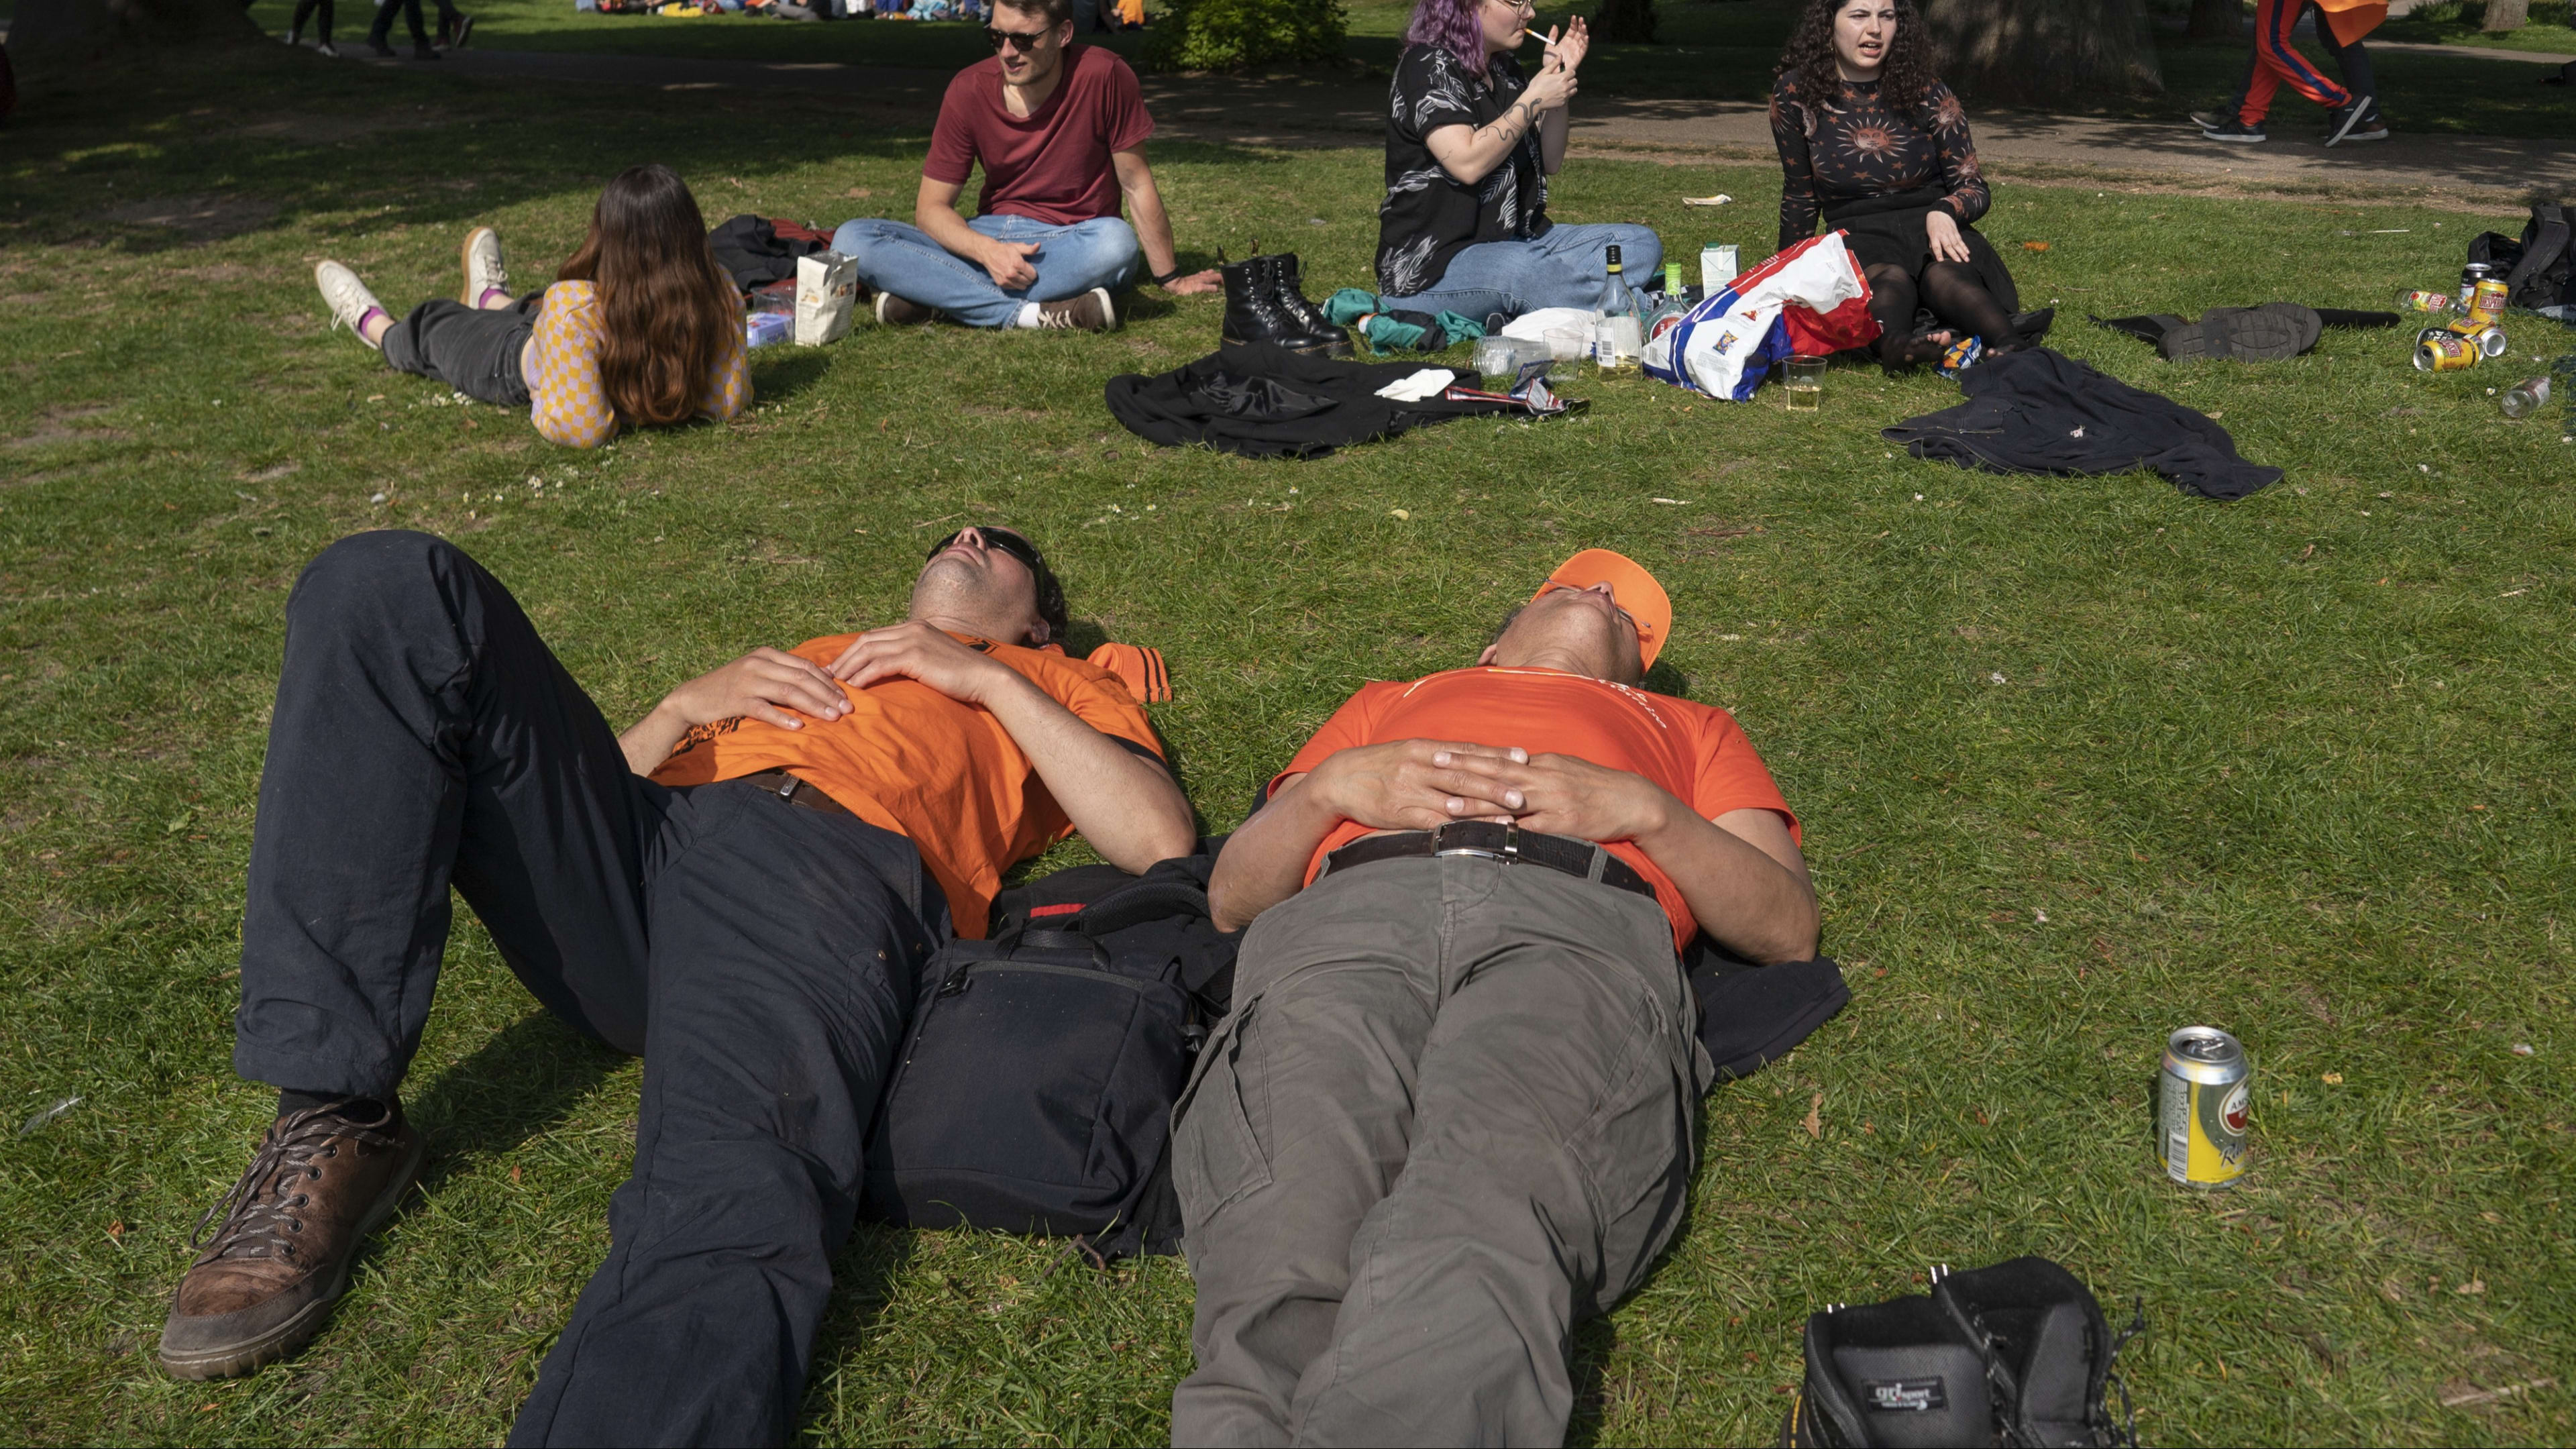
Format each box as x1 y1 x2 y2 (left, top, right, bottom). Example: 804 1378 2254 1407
652 634 1162 938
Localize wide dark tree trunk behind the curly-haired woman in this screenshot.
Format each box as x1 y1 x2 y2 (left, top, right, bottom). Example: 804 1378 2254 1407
1922 0 2164 101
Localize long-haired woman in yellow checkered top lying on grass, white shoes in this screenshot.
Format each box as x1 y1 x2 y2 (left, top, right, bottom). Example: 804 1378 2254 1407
314 165 752 449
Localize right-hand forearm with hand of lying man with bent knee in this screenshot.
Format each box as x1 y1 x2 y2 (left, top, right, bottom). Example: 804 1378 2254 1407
829 621 1198 871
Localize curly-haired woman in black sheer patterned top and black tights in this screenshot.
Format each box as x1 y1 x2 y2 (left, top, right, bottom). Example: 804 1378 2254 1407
1770 0 2045 366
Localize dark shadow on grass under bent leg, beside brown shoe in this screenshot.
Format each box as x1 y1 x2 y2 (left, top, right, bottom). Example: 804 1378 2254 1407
405 1011 626 1191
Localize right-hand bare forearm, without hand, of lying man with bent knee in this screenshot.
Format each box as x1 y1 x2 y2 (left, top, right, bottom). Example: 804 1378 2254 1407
984 673 1198 871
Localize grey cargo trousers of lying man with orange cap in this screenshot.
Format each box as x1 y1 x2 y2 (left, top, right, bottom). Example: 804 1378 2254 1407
1172 856 1713 1444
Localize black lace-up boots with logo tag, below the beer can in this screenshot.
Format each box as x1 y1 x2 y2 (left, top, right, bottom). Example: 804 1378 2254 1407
1780 1258 2146 1449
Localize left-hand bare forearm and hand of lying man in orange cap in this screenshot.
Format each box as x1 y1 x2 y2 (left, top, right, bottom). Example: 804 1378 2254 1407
1208 740 1522 930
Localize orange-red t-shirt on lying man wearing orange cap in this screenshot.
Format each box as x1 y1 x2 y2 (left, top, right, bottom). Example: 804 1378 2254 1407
1273 667 1798 949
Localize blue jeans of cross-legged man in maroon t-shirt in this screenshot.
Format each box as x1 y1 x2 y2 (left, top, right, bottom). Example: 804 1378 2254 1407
832 217 1136 327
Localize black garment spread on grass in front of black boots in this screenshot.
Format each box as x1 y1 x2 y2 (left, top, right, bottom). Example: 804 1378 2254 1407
1108 343 1538 459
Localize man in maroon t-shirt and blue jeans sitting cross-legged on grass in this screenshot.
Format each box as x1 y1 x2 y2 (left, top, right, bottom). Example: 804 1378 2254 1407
832 0 1216 333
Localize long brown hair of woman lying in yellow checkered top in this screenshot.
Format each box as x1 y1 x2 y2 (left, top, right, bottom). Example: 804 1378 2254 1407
554 165 742 425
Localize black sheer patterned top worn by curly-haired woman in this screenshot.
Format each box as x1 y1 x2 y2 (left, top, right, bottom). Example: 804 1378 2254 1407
1772 70 1991 248
